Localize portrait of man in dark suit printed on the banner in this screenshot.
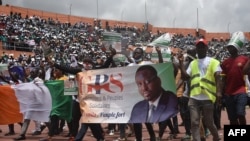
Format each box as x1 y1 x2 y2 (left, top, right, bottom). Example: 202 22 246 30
129 65 178 123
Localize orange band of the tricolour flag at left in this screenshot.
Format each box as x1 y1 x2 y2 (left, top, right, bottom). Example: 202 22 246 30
0 86 23 125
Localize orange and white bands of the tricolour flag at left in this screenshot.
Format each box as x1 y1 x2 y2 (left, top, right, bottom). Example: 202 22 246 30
0 82 52 125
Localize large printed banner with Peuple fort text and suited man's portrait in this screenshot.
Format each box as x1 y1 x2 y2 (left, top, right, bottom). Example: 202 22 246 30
77 63 178 123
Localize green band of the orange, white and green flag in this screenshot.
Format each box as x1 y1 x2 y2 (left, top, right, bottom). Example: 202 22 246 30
45 80 72 121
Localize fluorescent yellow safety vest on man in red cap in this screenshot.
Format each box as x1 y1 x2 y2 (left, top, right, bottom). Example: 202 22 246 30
190 58 220 103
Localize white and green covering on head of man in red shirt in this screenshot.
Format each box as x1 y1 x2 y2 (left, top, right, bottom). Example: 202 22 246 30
227 31 245 50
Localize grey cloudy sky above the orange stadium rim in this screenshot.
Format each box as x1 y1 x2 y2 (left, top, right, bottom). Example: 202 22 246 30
2 0 250 33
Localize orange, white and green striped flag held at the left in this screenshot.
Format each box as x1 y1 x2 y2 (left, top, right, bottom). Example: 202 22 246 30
0 81 72 125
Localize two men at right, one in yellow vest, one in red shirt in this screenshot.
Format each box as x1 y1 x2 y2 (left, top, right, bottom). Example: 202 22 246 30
179 32 250 141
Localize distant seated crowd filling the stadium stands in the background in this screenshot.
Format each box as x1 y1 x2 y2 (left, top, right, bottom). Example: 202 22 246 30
0 13 249 63
